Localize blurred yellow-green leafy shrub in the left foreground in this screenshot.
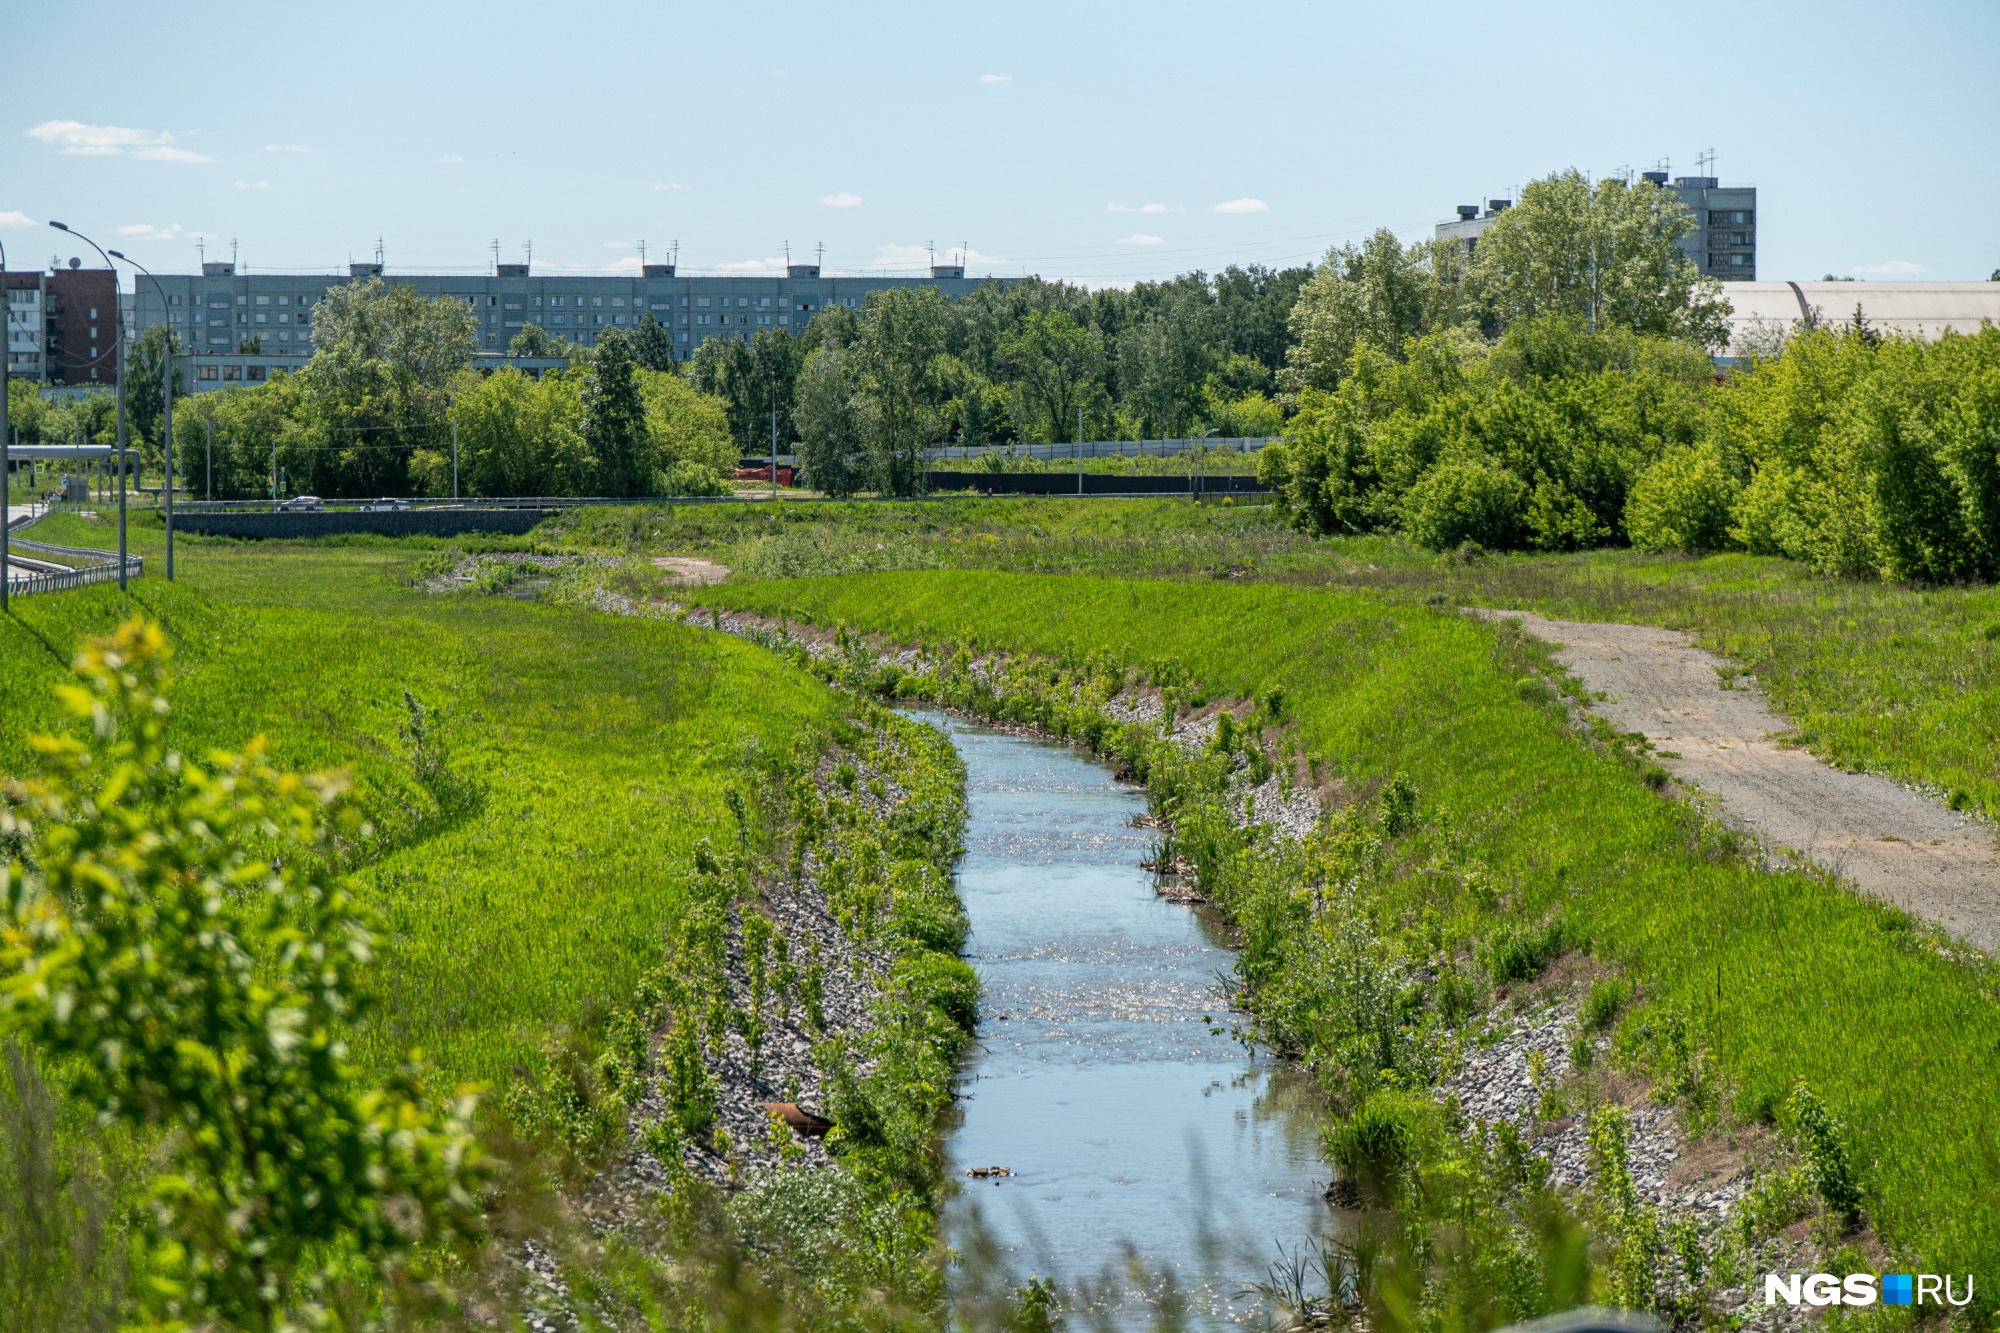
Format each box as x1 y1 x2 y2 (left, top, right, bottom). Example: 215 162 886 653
0 620 482 1333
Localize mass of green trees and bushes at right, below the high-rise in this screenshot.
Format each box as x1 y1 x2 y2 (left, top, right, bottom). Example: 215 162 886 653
1258 172 2000 580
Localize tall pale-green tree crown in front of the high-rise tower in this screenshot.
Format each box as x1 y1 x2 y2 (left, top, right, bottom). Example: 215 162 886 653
1474 168 1730 348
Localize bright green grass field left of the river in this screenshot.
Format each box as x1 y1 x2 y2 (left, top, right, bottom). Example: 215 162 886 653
0 506 840 1087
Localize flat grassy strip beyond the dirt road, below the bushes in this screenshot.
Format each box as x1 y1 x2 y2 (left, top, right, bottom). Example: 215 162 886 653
542 498 2000 819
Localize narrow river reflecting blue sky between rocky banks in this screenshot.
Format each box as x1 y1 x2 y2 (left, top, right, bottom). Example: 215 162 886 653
922 713 1328 1323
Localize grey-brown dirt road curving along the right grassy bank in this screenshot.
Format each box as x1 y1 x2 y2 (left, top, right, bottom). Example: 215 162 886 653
1478 610 2000 951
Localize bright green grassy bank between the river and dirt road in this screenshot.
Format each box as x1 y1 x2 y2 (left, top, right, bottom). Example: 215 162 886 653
700 570 2000 1273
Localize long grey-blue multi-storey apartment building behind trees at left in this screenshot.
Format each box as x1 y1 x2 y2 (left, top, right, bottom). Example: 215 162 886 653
128 262 980 388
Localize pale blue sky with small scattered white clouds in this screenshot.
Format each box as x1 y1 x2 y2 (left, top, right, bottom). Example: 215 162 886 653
0 0 2000 284
